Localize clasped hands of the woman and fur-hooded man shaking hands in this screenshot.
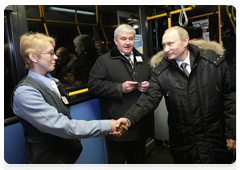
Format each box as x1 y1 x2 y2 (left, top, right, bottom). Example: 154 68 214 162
109 118 129 137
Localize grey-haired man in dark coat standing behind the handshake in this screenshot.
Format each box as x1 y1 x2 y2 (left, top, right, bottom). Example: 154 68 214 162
88 25 151 170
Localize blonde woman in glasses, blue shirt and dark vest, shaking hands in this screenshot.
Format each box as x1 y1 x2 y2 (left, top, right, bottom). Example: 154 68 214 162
11 33 123 170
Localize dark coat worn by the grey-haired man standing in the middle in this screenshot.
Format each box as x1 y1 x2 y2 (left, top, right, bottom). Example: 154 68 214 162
88 46 151 141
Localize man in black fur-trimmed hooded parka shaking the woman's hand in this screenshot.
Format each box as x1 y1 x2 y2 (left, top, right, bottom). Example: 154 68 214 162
116 26 238 170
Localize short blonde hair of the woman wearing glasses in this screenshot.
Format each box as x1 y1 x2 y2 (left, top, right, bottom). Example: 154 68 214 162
20 33 55 69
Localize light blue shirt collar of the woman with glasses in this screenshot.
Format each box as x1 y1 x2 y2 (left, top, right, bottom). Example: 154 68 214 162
28 70 54 89
